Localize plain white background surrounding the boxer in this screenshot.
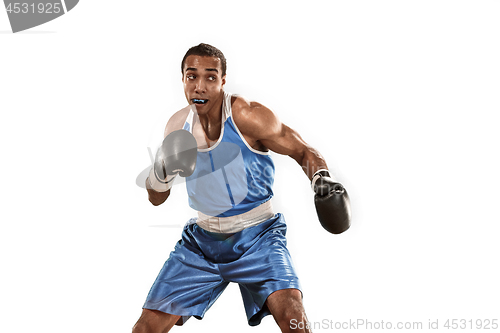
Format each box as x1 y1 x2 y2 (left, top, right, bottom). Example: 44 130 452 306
0 0 500 333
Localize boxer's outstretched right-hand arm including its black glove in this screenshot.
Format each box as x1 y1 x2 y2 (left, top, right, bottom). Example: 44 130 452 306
238 103 351 234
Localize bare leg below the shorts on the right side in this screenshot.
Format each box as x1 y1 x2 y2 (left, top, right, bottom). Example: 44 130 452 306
266 289 311 333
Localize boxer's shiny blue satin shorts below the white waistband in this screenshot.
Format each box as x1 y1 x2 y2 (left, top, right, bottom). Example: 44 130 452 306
143 214 301 326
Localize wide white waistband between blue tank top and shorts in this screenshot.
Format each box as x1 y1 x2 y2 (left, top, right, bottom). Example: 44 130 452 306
196 200 274 234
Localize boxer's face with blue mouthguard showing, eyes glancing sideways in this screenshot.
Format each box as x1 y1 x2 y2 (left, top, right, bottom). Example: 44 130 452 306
182 55 226 114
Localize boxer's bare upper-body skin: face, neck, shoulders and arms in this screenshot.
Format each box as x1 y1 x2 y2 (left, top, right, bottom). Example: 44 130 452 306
146 55 328 206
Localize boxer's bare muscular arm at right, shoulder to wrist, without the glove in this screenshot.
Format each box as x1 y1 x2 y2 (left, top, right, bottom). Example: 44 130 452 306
233 100 328 180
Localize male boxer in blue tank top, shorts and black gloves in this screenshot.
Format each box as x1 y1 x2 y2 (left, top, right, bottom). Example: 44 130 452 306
133 44 350 333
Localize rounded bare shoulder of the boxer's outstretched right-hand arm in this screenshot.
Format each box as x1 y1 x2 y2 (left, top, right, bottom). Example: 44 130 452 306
231 96 281 140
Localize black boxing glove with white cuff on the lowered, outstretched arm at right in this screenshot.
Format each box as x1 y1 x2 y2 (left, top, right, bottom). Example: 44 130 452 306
311 170 351 234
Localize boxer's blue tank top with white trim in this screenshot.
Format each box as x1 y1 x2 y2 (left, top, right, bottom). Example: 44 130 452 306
184 92 274 217
